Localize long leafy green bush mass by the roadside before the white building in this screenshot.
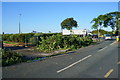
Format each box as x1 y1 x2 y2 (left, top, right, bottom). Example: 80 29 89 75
37 34 92 52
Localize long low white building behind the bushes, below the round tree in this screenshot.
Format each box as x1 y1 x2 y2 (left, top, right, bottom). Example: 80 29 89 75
62 29 91 36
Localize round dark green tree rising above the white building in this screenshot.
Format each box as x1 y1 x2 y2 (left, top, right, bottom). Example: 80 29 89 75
61 18 78 30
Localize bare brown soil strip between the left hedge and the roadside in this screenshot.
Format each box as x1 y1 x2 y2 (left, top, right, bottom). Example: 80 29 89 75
4 43 68 58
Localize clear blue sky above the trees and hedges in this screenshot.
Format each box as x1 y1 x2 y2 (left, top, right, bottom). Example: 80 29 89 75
2 2 118 33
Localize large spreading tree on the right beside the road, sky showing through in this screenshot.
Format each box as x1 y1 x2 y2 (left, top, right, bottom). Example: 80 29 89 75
91 12 120 35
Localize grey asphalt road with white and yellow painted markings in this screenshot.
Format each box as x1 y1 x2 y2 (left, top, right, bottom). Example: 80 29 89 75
3 41 120 78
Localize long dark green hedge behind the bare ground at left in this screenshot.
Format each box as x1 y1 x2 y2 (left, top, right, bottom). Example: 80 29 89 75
2 33 60 43
